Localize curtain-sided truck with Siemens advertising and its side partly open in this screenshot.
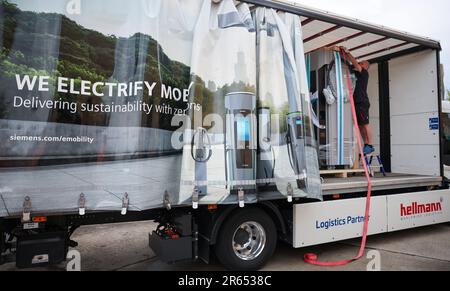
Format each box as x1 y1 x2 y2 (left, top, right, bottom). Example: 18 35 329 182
0 0 450 270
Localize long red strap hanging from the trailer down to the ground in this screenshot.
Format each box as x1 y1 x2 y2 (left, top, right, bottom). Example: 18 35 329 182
304 52 372 267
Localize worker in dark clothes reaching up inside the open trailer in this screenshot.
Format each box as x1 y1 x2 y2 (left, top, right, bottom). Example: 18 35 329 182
339 47 375 155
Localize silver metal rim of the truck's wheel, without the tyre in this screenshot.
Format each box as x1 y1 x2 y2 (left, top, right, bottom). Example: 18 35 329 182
232 221 266 261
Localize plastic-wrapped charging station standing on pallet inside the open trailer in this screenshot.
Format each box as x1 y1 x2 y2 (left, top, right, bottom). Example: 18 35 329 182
307 50 359 168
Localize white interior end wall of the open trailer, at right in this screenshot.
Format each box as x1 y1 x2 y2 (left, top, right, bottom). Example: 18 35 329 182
389 50 440 176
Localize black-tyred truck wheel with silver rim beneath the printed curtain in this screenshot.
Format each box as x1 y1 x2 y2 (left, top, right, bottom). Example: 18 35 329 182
215 208 277 271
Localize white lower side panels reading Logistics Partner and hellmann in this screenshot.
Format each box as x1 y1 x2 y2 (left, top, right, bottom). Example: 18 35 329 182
293 190 450 248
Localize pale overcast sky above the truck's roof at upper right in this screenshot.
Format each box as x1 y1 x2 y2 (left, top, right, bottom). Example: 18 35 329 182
291 0 450 89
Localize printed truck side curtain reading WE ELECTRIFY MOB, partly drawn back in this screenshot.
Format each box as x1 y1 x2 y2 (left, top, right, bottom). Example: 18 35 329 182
0 0 321 216
